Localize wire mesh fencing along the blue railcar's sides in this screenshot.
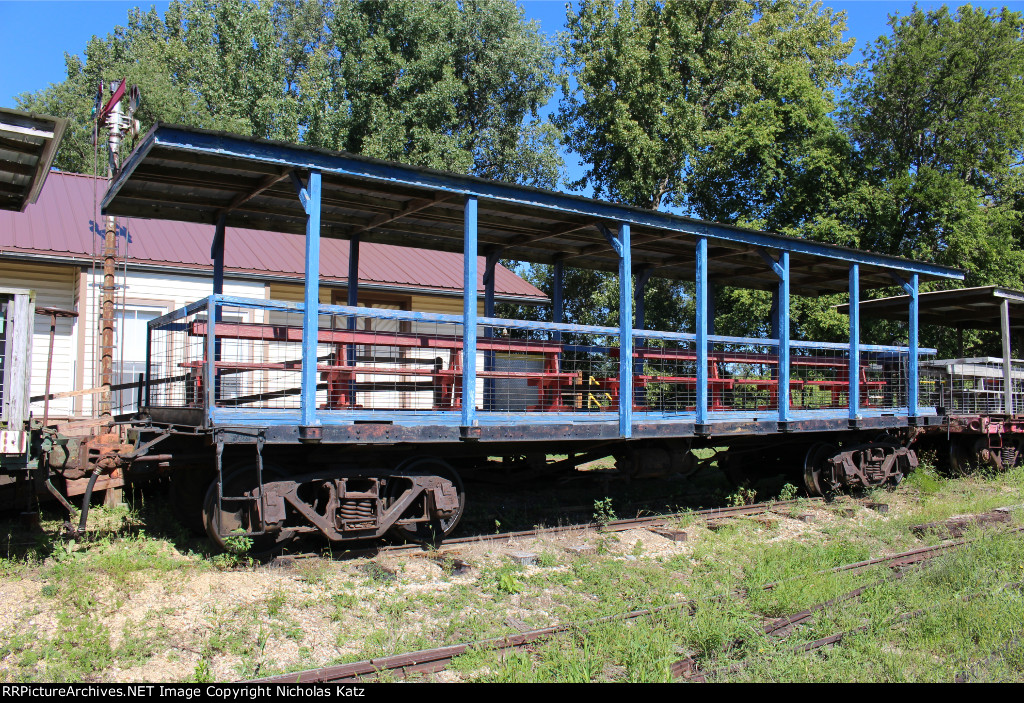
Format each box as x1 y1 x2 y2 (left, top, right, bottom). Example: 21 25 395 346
146 297 937 419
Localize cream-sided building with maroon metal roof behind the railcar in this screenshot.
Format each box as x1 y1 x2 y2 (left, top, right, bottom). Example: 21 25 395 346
0 172 547 419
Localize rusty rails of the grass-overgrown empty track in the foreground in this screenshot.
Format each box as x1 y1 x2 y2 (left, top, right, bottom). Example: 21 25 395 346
246 521 1024 684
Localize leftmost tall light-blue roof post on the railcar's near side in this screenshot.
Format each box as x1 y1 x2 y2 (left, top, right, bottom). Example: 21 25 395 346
300 171 321 427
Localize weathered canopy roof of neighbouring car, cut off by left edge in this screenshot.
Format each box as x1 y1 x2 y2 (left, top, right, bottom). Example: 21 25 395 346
0 107 68 212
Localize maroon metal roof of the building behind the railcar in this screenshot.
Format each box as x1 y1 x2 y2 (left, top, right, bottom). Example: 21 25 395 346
0 172 547 302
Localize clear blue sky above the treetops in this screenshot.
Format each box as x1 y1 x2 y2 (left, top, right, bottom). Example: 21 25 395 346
0 0 1024 107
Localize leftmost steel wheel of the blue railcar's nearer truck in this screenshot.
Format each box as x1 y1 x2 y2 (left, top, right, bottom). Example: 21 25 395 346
203 465 295 554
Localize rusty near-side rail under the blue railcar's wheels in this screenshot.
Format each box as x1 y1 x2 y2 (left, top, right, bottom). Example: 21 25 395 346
270 498 831 566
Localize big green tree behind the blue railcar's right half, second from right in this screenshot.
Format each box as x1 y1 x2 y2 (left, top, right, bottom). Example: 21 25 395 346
541 0 852 334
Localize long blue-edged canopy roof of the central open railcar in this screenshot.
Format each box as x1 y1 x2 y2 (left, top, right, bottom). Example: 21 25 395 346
102 125 964 295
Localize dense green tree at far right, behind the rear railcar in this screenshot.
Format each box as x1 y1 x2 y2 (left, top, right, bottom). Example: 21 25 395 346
834 5 1024 354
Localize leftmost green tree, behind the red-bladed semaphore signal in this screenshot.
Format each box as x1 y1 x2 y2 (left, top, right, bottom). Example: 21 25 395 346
17 0 298 173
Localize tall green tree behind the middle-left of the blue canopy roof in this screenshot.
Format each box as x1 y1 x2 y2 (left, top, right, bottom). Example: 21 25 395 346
285 0 561 187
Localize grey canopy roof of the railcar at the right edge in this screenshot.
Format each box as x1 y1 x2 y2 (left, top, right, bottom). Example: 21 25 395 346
837 285 1024 331
